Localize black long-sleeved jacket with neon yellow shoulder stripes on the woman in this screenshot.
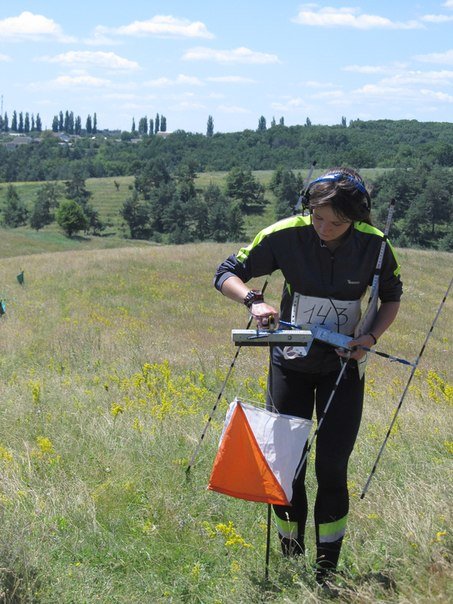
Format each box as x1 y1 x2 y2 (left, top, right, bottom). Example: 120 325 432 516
214 216 402 372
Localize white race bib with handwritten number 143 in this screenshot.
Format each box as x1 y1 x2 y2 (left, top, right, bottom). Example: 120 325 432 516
283 293 360 359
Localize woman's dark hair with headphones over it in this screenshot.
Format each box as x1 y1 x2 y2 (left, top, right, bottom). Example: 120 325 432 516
306 167 371 224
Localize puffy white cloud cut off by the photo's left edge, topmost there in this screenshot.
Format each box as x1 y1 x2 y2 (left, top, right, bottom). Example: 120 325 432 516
0 11 75 42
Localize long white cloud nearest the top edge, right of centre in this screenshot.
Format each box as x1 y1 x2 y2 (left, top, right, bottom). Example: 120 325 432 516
292 4 423 29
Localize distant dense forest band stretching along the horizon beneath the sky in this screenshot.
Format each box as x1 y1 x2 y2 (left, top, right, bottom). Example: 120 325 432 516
0 116 453 182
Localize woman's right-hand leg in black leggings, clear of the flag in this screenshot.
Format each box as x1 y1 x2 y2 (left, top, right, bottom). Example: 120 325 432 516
315 364 364 581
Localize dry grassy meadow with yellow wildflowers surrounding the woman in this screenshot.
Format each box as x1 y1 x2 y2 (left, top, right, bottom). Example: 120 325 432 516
0 239 453 604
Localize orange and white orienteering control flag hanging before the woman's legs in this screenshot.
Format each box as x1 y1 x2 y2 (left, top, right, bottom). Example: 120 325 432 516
208 399 313 505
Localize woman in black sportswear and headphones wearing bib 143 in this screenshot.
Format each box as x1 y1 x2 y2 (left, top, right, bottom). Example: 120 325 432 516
215 168 402 583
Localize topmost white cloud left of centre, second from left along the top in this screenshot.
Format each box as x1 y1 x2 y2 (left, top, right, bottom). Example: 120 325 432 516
106 15 215 39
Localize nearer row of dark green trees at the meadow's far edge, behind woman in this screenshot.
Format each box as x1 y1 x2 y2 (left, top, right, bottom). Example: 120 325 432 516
0 158 453 251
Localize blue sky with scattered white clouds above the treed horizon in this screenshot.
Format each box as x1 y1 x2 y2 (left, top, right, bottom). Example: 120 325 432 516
0 0 453 133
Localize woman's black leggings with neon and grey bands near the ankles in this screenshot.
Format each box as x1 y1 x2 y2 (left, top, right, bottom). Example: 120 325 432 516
267 361 364 568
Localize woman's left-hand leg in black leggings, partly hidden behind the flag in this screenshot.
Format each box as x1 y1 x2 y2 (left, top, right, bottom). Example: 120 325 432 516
267 364 314 555
